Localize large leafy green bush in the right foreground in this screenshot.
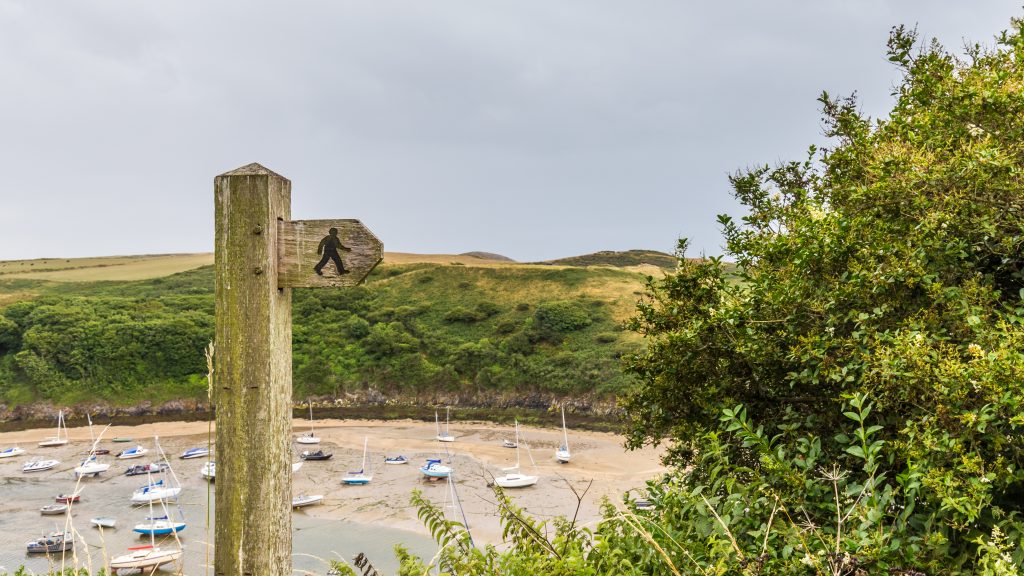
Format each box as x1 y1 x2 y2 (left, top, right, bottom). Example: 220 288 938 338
399 15 1024 576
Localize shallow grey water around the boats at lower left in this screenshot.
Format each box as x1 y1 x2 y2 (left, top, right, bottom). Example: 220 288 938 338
0 457 436 576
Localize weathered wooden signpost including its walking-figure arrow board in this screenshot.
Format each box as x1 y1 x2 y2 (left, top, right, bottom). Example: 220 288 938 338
214 164 384 576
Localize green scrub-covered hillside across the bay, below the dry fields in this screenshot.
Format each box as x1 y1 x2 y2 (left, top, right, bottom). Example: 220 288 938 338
0 253 644 405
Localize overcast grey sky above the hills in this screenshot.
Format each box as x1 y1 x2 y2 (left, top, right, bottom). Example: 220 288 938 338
0 0 1024 260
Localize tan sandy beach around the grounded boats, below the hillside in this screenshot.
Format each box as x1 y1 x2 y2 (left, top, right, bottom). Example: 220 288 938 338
0 418 664 565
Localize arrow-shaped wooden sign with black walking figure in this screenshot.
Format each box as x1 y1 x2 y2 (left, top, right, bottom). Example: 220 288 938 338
278 219 384 288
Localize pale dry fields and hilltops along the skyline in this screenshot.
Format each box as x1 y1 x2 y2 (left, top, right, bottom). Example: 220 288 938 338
0 250 676 282
